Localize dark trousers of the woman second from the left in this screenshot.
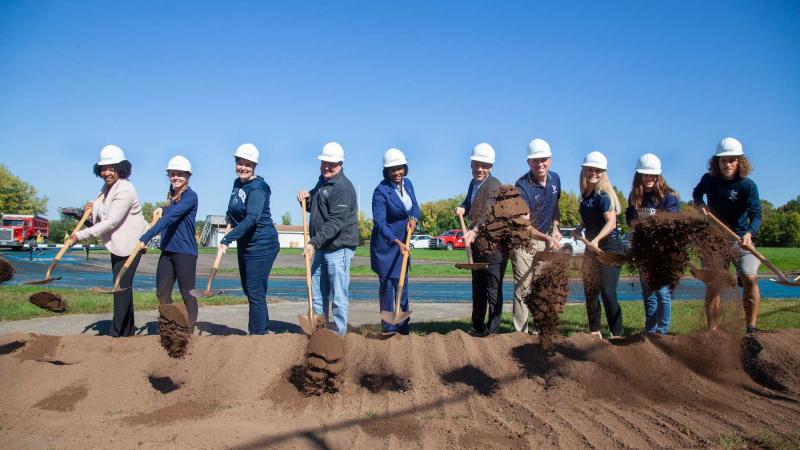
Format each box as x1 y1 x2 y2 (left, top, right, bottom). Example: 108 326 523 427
156 251 197 329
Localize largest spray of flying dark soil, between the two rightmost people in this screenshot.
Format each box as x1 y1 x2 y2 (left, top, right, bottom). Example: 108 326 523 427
629 214 733 289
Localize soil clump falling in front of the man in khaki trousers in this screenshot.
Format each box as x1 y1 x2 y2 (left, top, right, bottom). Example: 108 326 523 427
525 253 570 349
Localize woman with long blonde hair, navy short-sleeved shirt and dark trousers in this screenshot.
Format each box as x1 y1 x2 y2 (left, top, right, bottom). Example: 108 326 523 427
573 152 623 338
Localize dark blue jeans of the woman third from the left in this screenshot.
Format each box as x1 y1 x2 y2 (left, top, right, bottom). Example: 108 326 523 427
236 242 279 334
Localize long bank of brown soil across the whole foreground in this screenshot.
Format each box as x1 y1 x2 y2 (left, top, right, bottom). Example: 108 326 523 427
0 330 800 449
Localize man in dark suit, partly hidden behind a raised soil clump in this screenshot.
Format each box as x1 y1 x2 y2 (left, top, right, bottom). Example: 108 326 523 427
456 143 508 336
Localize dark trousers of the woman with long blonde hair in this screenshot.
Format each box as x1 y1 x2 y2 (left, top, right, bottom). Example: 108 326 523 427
581 239 623 336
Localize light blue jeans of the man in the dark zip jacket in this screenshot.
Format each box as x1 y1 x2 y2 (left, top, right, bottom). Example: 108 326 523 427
311 248 356 336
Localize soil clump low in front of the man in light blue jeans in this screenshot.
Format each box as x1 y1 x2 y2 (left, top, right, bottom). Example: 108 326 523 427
289 329 344 396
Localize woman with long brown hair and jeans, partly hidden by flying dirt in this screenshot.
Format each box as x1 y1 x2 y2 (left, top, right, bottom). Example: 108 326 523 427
625 153 680 334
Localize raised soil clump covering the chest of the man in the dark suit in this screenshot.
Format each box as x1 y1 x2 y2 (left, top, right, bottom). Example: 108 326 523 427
475 185 532 255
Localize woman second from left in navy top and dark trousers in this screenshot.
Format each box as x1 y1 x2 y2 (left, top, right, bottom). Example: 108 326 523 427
139 156 197 331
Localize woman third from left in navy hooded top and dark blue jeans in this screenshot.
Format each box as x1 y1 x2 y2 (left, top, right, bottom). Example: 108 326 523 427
219 144 280 334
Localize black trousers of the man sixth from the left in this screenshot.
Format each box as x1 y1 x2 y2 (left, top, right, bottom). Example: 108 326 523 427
472 253 508 334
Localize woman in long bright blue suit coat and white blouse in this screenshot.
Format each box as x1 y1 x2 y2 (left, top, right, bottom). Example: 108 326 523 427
369 148 419 334
